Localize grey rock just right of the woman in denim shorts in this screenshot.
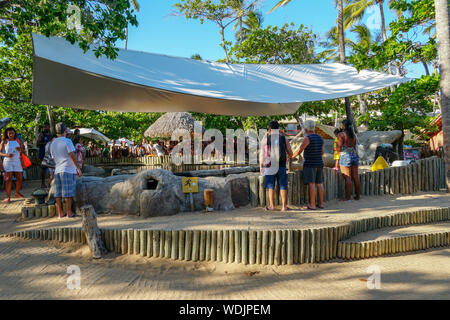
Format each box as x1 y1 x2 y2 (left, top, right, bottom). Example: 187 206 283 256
358 130 402 161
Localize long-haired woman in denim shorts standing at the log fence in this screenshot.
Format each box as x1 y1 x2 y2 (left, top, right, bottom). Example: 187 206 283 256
336 119 361 201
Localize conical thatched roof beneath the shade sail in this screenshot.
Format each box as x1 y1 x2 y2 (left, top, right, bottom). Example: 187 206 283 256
144 112 204 138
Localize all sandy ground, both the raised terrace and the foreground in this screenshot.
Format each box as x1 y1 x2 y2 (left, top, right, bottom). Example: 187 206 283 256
0 179 450 300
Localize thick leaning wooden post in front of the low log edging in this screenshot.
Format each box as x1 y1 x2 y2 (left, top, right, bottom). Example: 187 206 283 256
80 205 106 259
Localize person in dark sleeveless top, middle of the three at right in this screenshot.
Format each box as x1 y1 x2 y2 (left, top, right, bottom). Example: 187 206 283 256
293 120 325 210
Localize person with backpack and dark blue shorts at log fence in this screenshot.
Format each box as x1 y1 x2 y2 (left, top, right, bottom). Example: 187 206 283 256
259 120 293 211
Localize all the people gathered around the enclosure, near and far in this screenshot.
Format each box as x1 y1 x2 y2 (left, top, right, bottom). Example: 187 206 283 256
0 120 360 217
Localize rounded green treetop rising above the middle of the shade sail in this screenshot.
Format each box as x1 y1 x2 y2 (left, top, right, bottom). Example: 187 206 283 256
231 23 317 64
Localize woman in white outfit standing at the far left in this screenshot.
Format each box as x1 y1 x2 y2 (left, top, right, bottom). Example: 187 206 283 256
0 127 23 203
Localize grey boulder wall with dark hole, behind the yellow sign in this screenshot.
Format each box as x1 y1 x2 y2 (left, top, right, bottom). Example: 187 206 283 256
50 169 237 217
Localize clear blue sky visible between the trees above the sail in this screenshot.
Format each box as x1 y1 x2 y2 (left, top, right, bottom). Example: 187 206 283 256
118 0 423 77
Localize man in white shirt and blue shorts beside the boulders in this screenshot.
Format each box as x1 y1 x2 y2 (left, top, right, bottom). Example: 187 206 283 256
50 122 82 219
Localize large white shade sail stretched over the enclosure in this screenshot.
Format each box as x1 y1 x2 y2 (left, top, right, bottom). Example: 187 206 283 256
33 34 409 116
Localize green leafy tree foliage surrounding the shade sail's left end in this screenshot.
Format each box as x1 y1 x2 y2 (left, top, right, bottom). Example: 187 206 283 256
0 0 141 141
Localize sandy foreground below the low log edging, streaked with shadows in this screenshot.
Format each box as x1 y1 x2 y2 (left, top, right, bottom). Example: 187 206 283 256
0 238 450 300
